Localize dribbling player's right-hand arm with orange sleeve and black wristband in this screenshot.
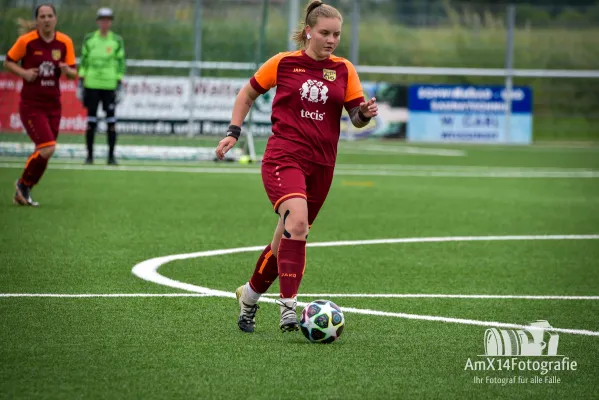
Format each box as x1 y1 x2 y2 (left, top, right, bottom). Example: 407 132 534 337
344 60 378 128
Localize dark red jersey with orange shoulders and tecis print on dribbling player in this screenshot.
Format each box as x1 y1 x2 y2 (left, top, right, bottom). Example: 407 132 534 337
250 51 364 166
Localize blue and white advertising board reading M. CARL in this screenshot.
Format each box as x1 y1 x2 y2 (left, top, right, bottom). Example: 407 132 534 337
407 85 532 144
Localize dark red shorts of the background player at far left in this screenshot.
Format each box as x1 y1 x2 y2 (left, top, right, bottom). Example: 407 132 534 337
19 103 61 149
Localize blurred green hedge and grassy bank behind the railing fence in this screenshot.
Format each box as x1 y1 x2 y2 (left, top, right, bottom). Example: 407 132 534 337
0 1 599 139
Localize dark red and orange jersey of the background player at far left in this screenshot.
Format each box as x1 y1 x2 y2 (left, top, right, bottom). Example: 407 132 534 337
6 30 75 108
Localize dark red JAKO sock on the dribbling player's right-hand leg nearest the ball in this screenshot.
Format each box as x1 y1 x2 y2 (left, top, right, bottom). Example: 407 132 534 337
278 238 306 299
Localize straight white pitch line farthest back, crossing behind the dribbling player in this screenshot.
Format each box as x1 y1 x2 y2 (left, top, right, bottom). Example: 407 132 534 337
0 162 599 178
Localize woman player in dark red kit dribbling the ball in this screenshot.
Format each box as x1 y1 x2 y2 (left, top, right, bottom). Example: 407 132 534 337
216 1 378 332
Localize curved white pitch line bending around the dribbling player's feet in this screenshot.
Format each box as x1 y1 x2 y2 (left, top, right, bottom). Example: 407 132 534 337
132 235 599 337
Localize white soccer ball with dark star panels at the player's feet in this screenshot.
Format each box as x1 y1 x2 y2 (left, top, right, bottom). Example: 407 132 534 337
300 300 345 343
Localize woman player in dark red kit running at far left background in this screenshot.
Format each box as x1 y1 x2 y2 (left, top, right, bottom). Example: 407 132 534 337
4 4 77 206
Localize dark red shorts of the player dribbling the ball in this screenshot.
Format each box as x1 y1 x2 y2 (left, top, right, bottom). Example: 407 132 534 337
262 159 335 225
